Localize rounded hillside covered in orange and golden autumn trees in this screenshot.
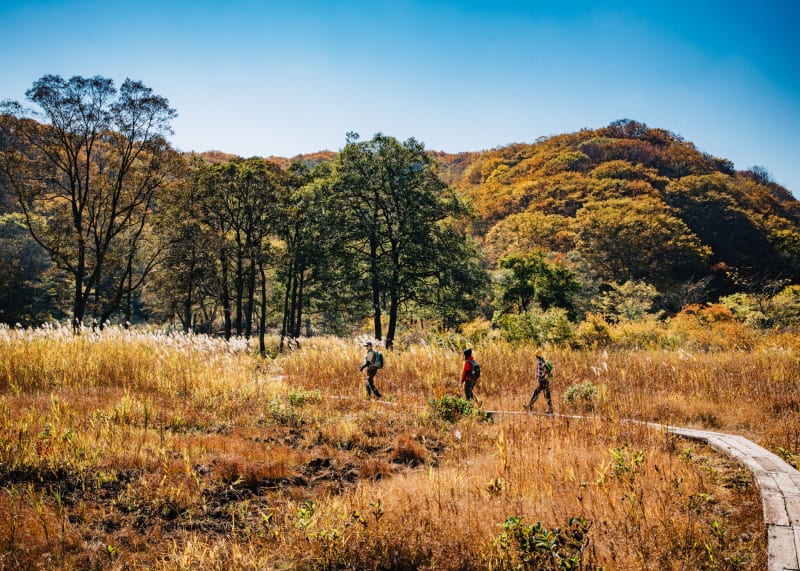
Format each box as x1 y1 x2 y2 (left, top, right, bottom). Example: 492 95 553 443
440 120 800 300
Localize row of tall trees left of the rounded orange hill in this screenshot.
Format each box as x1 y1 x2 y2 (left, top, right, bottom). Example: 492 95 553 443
0 75 486 350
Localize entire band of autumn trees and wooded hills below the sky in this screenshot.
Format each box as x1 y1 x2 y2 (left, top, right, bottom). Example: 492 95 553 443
0 76 800 344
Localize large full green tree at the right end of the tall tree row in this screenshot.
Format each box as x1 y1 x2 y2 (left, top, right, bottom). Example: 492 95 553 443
335 133 482 347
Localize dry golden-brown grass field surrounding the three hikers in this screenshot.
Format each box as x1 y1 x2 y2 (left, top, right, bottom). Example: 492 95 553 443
0 329 800 571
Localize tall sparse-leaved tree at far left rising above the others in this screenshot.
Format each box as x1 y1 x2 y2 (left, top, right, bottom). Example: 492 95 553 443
0 75 176 329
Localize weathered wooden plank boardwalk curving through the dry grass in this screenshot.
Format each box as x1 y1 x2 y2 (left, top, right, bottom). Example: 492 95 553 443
486 411 800 571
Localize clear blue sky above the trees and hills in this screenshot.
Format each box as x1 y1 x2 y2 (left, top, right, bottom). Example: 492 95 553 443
0 0 800 196
